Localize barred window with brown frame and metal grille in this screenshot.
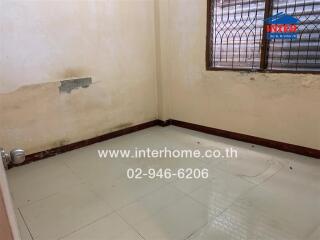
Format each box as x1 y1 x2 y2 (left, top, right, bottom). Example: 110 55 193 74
207 0 320 72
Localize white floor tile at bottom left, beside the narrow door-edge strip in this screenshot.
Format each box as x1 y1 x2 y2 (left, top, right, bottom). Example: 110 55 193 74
21 185 111 240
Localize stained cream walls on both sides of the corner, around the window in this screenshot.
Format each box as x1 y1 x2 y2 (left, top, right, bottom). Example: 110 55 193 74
0 0 320 153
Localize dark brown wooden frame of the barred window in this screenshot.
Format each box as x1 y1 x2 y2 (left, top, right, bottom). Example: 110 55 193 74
206 0 320 74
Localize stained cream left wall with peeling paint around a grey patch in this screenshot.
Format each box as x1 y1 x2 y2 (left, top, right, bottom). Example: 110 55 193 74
0 0 158 154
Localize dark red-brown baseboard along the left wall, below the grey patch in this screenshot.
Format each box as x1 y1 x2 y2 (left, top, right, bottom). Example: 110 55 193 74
14 120 162 167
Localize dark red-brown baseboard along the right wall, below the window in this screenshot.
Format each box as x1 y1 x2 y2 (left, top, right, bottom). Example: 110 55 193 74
168 119 320 159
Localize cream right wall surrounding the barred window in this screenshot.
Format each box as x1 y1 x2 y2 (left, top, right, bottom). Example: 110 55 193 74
159 0 320 149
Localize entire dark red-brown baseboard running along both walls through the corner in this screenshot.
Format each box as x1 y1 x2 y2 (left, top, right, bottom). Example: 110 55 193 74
14 119 320 167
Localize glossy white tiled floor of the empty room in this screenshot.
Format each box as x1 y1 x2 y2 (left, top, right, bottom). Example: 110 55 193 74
8 126 320 240
